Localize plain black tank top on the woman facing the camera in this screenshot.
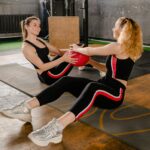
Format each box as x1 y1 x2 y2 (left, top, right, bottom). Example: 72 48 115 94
24 39 50 69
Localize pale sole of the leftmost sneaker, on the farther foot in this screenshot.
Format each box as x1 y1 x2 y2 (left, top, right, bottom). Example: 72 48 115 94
2 112 31 123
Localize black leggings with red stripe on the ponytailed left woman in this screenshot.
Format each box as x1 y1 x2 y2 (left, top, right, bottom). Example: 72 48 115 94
38 56 73 85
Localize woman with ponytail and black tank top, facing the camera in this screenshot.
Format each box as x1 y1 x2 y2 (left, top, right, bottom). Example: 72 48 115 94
21 16 76 85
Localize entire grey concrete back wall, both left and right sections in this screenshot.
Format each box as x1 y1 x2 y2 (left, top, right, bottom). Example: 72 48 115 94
0 0 150 44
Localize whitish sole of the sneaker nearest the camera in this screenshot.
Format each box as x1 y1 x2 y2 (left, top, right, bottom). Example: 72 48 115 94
28 134 62 147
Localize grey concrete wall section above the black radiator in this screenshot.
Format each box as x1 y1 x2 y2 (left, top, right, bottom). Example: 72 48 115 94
0 0 39 15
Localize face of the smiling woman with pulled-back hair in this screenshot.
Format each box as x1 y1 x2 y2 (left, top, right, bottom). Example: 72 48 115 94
26 19 41 36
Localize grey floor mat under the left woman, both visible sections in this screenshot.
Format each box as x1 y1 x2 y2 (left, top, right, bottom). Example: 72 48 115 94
0 64 99 96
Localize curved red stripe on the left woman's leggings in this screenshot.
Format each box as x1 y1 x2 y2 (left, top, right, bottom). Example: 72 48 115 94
47 64 72 79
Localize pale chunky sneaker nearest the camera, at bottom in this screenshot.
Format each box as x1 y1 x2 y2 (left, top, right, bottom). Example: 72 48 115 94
28 118 63 146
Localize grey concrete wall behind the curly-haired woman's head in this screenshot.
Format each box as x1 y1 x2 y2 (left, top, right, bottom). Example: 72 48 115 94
76 0 150 44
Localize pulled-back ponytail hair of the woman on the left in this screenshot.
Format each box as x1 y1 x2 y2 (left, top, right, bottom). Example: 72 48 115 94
21 16 39 40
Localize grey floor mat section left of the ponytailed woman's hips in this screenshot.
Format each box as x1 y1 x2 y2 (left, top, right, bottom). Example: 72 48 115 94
0 64 47 96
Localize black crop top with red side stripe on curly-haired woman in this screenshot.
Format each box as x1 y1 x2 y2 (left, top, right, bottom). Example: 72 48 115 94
106 55 134 81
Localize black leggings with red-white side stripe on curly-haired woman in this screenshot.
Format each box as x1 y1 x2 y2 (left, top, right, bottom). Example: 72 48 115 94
36 76 125 120
